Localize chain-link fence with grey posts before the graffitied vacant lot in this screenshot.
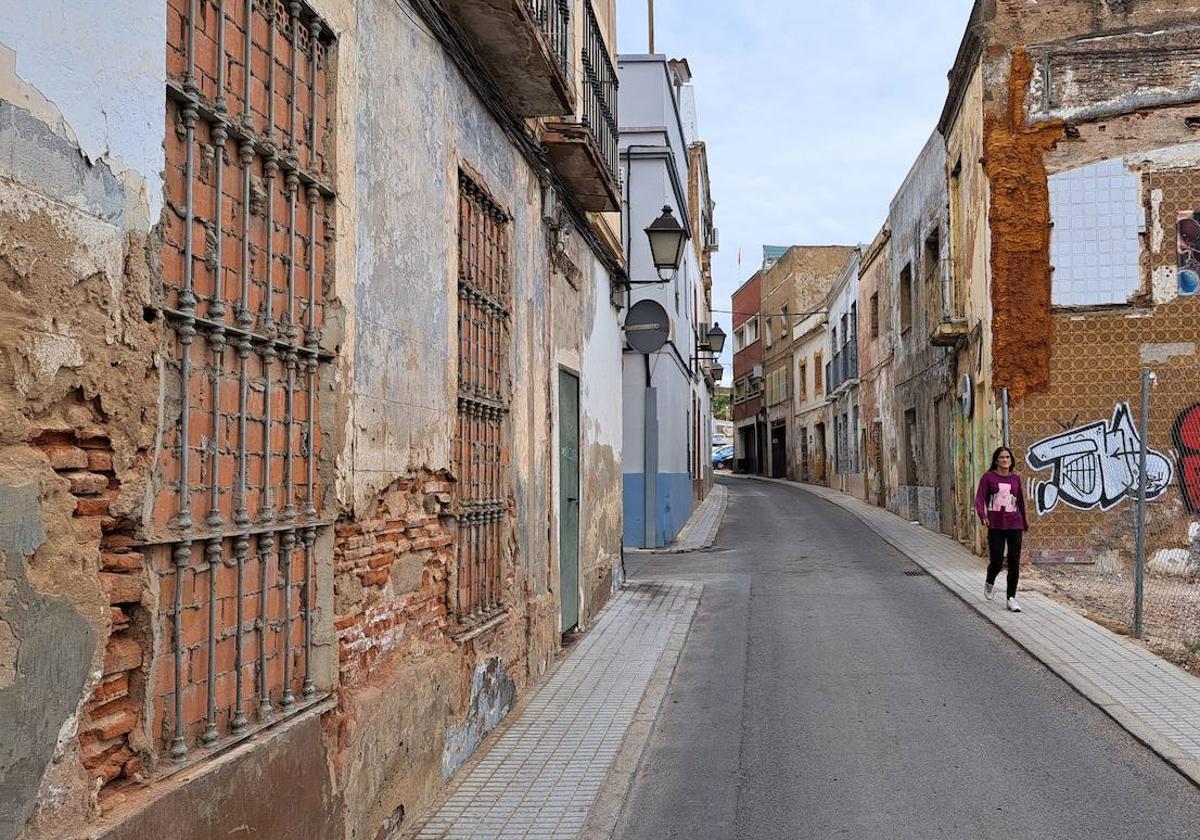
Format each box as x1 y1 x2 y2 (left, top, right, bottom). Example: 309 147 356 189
1009 358 1200 670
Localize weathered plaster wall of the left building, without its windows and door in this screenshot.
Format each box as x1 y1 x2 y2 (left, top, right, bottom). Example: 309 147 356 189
7 0 622 840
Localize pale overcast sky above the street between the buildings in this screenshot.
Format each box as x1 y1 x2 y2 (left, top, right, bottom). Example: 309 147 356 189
617 0 971 380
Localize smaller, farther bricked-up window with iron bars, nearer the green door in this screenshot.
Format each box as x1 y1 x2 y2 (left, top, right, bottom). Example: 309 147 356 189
451 173 512 624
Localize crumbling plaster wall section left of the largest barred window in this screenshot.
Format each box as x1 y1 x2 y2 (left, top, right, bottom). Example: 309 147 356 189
0 8 166 839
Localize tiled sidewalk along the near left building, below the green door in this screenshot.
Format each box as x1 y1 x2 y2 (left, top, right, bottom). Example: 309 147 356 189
416 581 701 840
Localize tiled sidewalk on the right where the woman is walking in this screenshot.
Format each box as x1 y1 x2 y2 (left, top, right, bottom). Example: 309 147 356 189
755 476 1200 785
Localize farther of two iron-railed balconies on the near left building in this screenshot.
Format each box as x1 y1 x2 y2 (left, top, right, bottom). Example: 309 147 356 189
541 0 620 212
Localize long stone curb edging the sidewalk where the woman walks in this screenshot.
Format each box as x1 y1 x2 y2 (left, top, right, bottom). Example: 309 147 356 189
748 476 1200 787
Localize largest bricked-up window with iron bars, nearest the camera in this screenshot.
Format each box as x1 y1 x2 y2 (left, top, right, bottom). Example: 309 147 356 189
143 0 335 767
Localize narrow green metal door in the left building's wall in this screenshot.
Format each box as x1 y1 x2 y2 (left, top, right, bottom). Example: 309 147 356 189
558 371 580 631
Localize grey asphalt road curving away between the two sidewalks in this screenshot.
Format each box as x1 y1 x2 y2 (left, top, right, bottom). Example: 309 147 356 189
616 479 1200 840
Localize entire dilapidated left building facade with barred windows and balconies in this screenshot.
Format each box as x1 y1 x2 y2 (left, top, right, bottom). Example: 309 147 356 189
0 0 624 839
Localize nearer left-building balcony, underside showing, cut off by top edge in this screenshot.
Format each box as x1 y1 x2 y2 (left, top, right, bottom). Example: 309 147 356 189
445 0 575 116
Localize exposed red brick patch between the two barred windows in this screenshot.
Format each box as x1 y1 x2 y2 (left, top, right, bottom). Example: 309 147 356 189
334 473 455 686
